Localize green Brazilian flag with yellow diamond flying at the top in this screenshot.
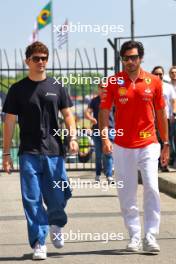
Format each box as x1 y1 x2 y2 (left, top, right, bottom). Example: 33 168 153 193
37 2 52 30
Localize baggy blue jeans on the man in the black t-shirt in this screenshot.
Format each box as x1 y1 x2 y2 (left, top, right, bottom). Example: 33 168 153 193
19 154 71 248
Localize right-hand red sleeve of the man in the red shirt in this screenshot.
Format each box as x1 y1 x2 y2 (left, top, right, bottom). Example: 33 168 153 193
154 79 165 110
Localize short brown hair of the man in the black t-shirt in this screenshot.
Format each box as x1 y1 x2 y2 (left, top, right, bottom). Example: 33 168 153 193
25 41 49 59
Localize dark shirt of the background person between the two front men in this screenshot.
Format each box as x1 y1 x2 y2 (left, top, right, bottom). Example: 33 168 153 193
88 96 114 129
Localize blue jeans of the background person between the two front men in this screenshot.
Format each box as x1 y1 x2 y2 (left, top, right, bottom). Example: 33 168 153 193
92 135 113 177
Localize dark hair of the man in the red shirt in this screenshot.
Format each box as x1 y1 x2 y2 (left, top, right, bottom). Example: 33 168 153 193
120 40 144 58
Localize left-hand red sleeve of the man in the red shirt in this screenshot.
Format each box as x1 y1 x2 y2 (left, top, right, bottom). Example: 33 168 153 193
100 77 114 109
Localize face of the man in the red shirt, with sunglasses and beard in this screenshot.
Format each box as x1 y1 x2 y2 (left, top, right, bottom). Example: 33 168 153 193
122 48 142 73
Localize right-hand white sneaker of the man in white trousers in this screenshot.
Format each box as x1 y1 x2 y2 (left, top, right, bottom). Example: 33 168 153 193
143 233 160 252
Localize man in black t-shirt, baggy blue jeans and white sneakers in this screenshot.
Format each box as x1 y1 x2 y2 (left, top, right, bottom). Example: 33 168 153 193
3 42 78 259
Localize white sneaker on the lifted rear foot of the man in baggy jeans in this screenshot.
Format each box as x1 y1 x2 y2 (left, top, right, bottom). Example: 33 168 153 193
50 225 64 248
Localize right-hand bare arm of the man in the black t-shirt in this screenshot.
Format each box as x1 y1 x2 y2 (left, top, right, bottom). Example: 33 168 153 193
61 107 78 153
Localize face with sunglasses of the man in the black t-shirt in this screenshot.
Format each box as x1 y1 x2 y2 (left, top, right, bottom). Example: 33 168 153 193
26 53 48 73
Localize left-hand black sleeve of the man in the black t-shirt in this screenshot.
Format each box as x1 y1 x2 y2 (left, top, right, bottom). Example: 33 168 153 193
2 85 18 115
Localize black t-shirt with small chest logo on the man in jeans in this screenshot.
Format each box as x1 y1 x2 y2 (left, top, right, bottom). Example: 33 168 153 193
3 77 73 155
